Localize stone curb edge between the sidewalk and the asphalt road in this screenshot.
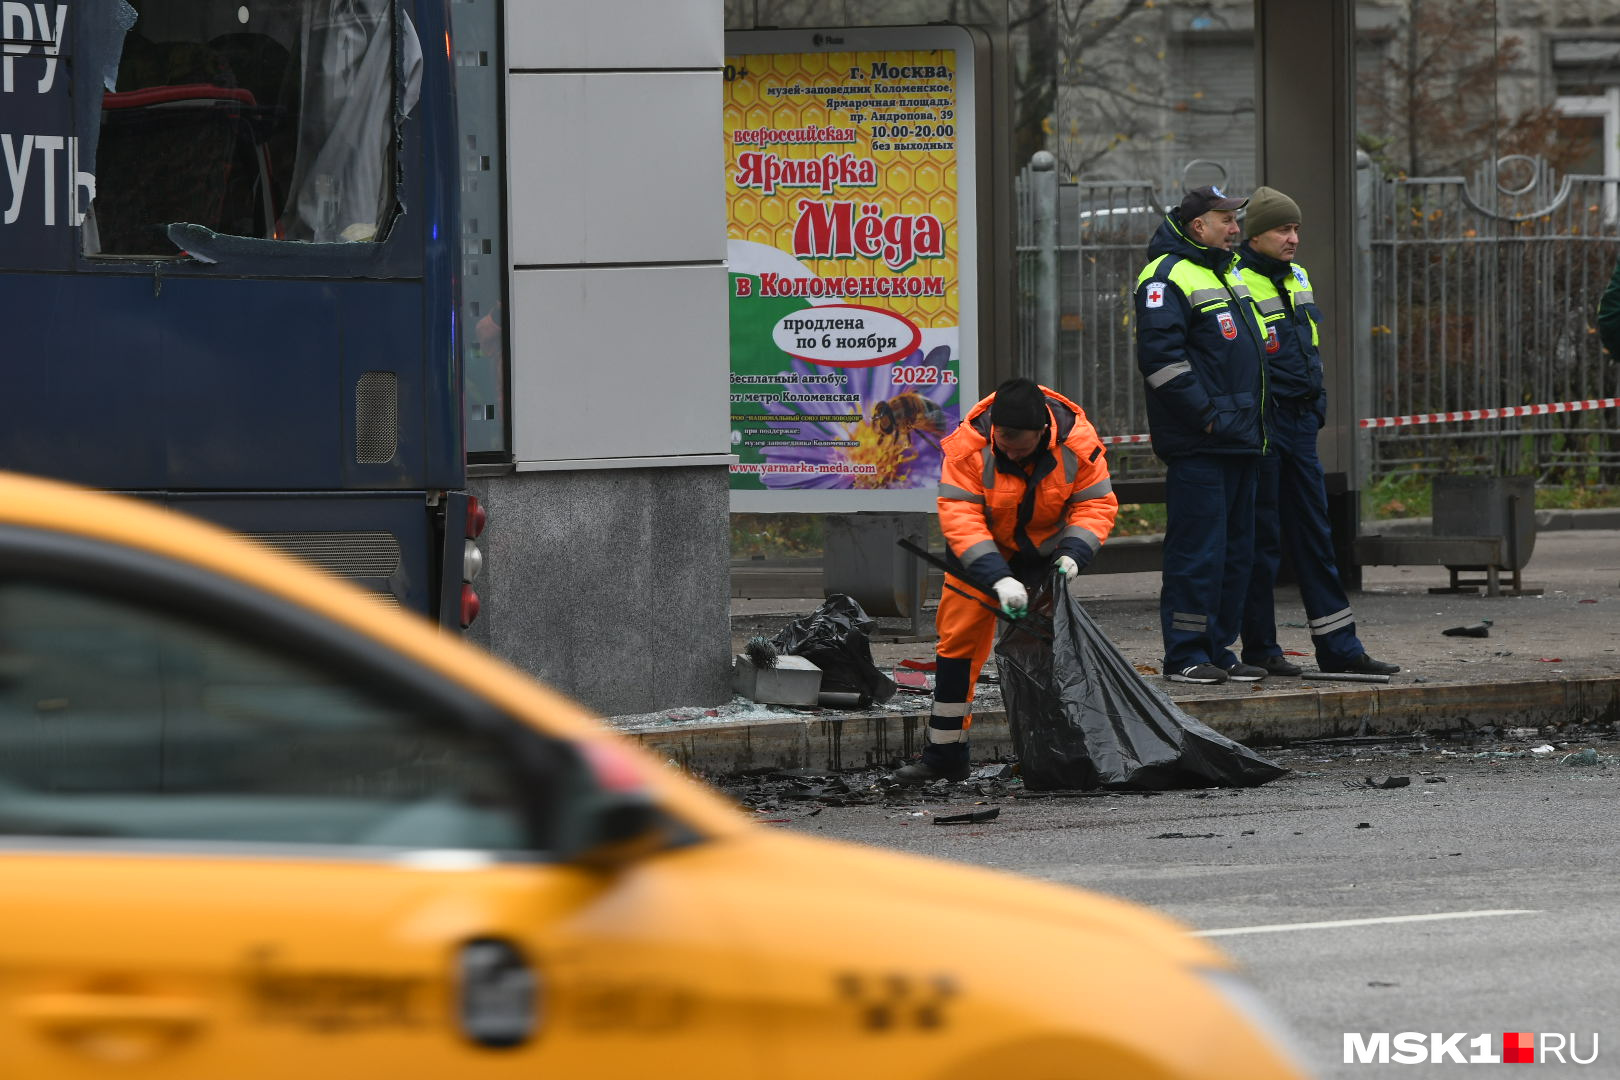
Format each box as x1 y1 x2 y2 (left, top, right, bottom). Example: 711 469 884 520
620 675 1620 777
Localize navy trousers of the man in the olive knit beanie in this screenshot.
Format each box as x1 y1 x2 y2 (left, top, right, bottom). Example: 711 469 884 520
1243 402 1366 667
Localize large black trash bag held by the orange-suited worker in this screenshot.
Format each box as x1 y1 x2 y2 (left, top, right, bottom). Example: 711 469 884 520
996 583 1288 792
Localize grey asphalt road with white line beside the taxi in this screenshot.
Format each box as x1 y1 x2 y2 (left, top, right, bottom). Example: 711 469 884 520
729 732 1620 1077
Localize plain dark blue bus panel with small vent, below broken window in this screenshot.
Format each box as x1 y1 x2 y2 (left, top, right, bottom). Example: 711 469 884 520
0 274 430 491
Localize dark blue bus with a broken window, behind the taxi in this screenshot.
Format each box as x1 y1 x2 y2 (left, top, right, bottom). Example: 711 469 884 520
0 0 502 627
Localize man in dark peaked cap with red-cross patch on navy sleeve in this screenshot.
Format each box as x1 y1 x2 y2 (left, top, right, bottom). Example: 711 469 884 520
1136 186 1265 683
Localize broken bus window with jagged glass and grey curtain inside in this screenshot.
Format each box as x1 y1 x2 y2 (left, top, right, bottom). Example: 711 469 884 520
84 0 421 256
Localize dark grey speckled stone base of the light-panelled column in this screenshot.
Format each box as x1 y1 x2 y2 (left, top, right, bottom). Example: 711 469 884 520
467 466 731 716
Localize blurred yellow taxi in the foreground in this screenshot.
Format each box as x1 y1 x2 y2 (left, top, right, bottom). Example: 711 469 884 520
0 474 1302 1080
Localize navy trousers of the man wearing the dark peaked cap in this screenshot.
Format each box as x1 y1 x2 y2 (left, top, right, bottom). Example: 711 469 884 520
1158 453 1260 674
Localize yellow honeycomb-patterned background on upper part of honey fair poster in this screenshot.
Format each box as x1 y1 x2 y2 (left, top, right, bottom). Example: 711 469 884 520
726 50 959 327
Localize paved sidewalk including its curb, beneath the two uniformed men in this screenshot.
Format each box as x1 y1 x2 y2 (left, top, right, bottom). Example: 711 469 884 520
612 521 1620 774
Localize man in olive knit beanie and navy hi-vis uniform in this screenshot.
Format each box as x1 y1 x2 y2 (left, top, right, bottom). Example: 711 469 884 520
1238 188 1401 675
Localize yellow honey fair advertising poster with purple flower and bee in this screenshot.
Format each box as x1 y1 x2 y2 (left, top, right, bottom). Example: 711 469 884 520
724 28 977 512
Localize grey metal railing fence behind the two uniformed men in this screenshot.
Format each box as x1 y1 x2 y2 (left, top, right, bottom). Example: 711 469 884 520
1017 159 1620 484
